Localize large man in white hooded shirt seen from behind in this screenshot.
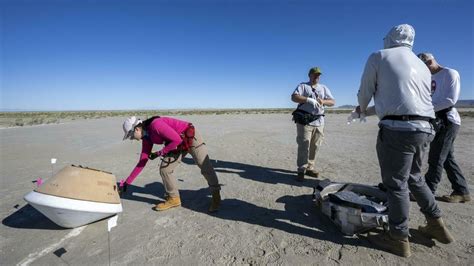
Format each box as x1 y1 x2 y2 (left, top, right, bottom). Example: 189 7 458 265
356 24 454 257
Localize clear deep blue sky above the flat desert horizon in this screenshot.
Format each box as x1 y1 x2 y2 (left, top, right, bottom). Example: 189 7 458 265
0 0 474 110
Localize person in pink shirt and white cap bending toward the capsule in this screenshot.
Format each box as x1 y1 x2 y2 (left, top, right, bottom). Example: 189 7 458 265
119 116 221 212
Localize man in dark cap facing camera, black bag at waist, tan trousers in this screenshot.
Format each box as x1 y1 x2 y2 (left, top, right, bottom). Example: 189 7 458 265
291 67 335 181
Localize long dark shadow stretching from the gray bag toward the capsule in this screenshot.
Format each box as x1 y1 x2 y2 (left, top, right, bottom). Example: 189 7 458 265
124 182 369 247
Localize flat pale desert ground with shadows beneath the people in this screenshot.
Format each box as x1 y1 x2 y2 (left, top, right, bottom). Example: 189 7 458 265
0 114 474 265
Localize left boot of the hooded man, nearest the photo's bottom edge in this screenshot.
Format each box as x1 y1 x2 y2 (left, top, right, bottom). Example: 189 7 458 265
367 233 411 258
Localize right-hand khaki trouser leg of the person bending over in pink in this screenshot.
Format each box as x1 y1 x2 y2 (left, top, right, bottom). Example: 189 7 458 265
189 130 220 192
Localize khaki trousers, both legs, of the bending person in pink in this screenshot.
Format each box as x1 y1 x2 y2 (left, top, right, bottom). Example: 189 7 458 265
160 129 220 196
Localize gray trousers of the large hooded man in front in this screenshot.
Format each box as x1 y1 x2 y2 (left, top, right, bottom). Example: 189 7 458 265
377 127 441 237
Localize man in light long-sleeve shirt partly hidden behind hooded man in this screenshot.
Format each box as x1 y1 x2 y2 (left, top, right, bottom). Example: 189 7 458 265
418 53 471 202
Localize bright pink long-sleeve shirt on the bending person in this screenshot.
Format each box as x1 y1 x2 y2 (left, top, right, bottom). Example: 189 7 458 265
126 117 190 184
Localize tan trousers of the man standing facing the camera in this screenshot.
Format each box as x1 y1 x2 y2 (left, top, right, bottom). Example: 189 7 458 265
296 124 324 172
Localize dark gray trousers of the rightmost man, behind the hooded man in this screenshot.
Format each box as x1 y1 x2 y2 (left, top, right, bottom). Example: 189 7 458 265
425 121 469 195
